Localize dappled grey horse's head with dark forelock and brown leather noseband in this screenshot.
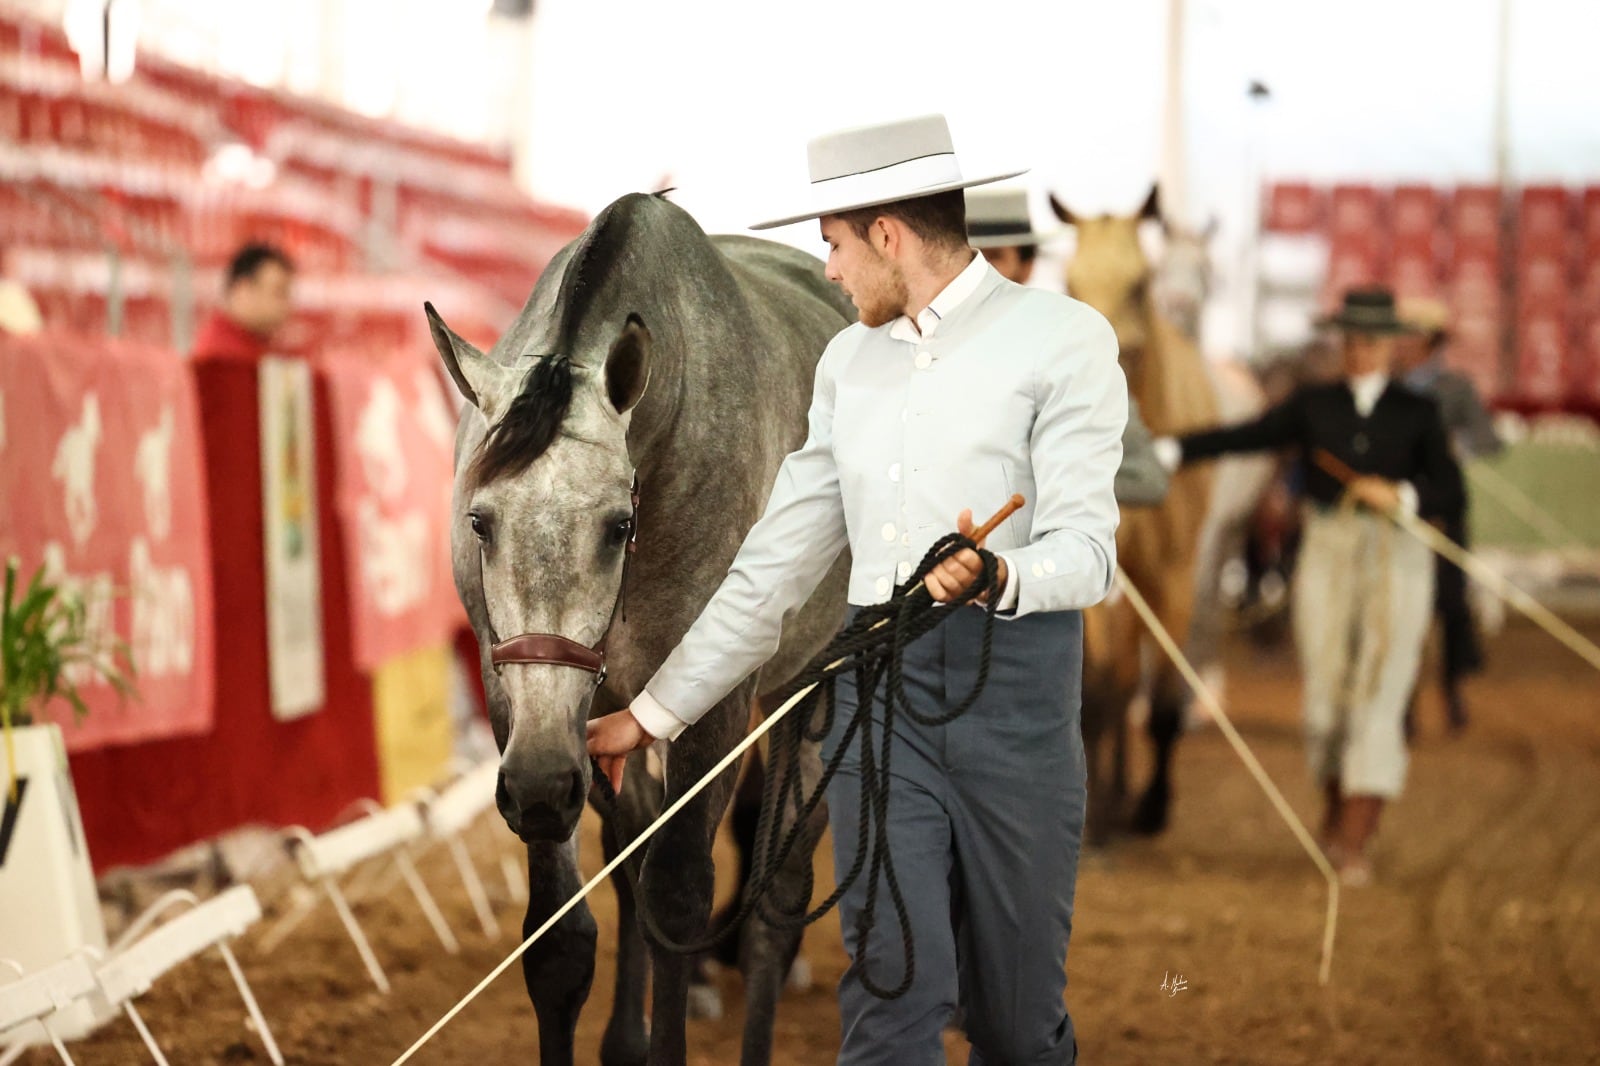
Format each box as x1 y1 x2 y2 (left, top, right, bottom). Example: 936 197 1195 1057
427 304 651 840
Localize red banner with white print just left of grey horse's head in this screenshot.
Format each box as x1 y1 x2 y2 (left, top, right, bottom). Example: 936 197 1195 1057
322 349 466 671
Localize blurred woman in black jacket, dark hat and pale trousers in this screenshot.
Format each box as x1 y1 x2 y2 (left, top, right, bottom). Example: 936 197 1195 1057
1155 288 1462 885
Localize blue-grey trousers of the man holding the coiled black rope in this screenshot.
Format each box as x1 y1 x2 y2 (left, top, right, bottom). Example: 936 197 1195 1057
824 608 1085 1066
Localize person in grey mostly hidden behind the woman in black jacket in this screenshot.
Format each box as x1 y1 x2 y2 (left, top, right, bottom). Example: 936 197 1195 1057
1395 299 1506 735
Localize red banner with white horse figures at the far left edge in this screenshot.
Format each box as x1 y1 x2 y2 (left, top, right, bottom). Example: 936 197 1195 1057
0 335 213 751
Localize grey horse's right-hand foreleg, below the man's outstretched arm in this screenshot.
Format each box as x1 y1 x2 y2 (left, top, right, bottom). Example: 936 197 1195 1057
638 688 749 1066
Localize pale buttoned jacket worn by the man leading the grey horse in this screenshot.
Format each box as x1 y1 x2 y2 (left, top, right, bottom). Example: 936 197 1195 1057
632 256 1128 739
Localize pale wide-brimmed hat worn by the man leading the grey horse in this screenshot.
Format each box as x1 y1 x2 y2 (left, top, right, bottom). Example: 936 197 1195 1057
750 115 1027 229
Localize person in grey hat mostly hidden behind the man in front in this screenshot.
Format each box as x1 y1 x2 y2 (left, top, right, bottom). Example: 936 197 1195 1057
966 189 1170 507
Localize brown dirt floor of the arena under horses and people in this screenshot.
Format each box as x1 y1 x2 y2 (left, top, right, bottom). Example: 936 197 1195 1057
24 626 1600 1066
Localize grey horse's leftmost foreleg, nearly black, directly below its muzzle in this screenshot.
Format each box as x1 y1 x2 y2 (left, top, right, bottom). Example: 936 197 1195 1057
522 834 595 1066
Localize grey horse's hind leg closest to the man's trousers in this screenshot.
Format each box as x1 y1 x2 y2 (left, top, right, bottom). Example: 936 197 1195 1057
739 729 827 1066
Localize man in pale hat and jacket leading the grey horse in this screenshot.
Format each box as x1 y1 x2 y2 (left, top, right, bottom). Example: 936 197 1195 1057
589 115 1128 1064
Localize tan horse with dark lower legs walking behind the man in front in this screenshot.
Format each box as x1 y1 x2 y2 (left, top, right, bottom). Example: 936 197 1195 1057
1051 189 1218 844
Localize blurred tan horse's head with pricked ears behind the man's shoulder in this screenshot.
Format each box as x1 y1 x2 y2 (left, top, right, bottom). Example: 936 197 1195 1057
1050 189 1162 355
